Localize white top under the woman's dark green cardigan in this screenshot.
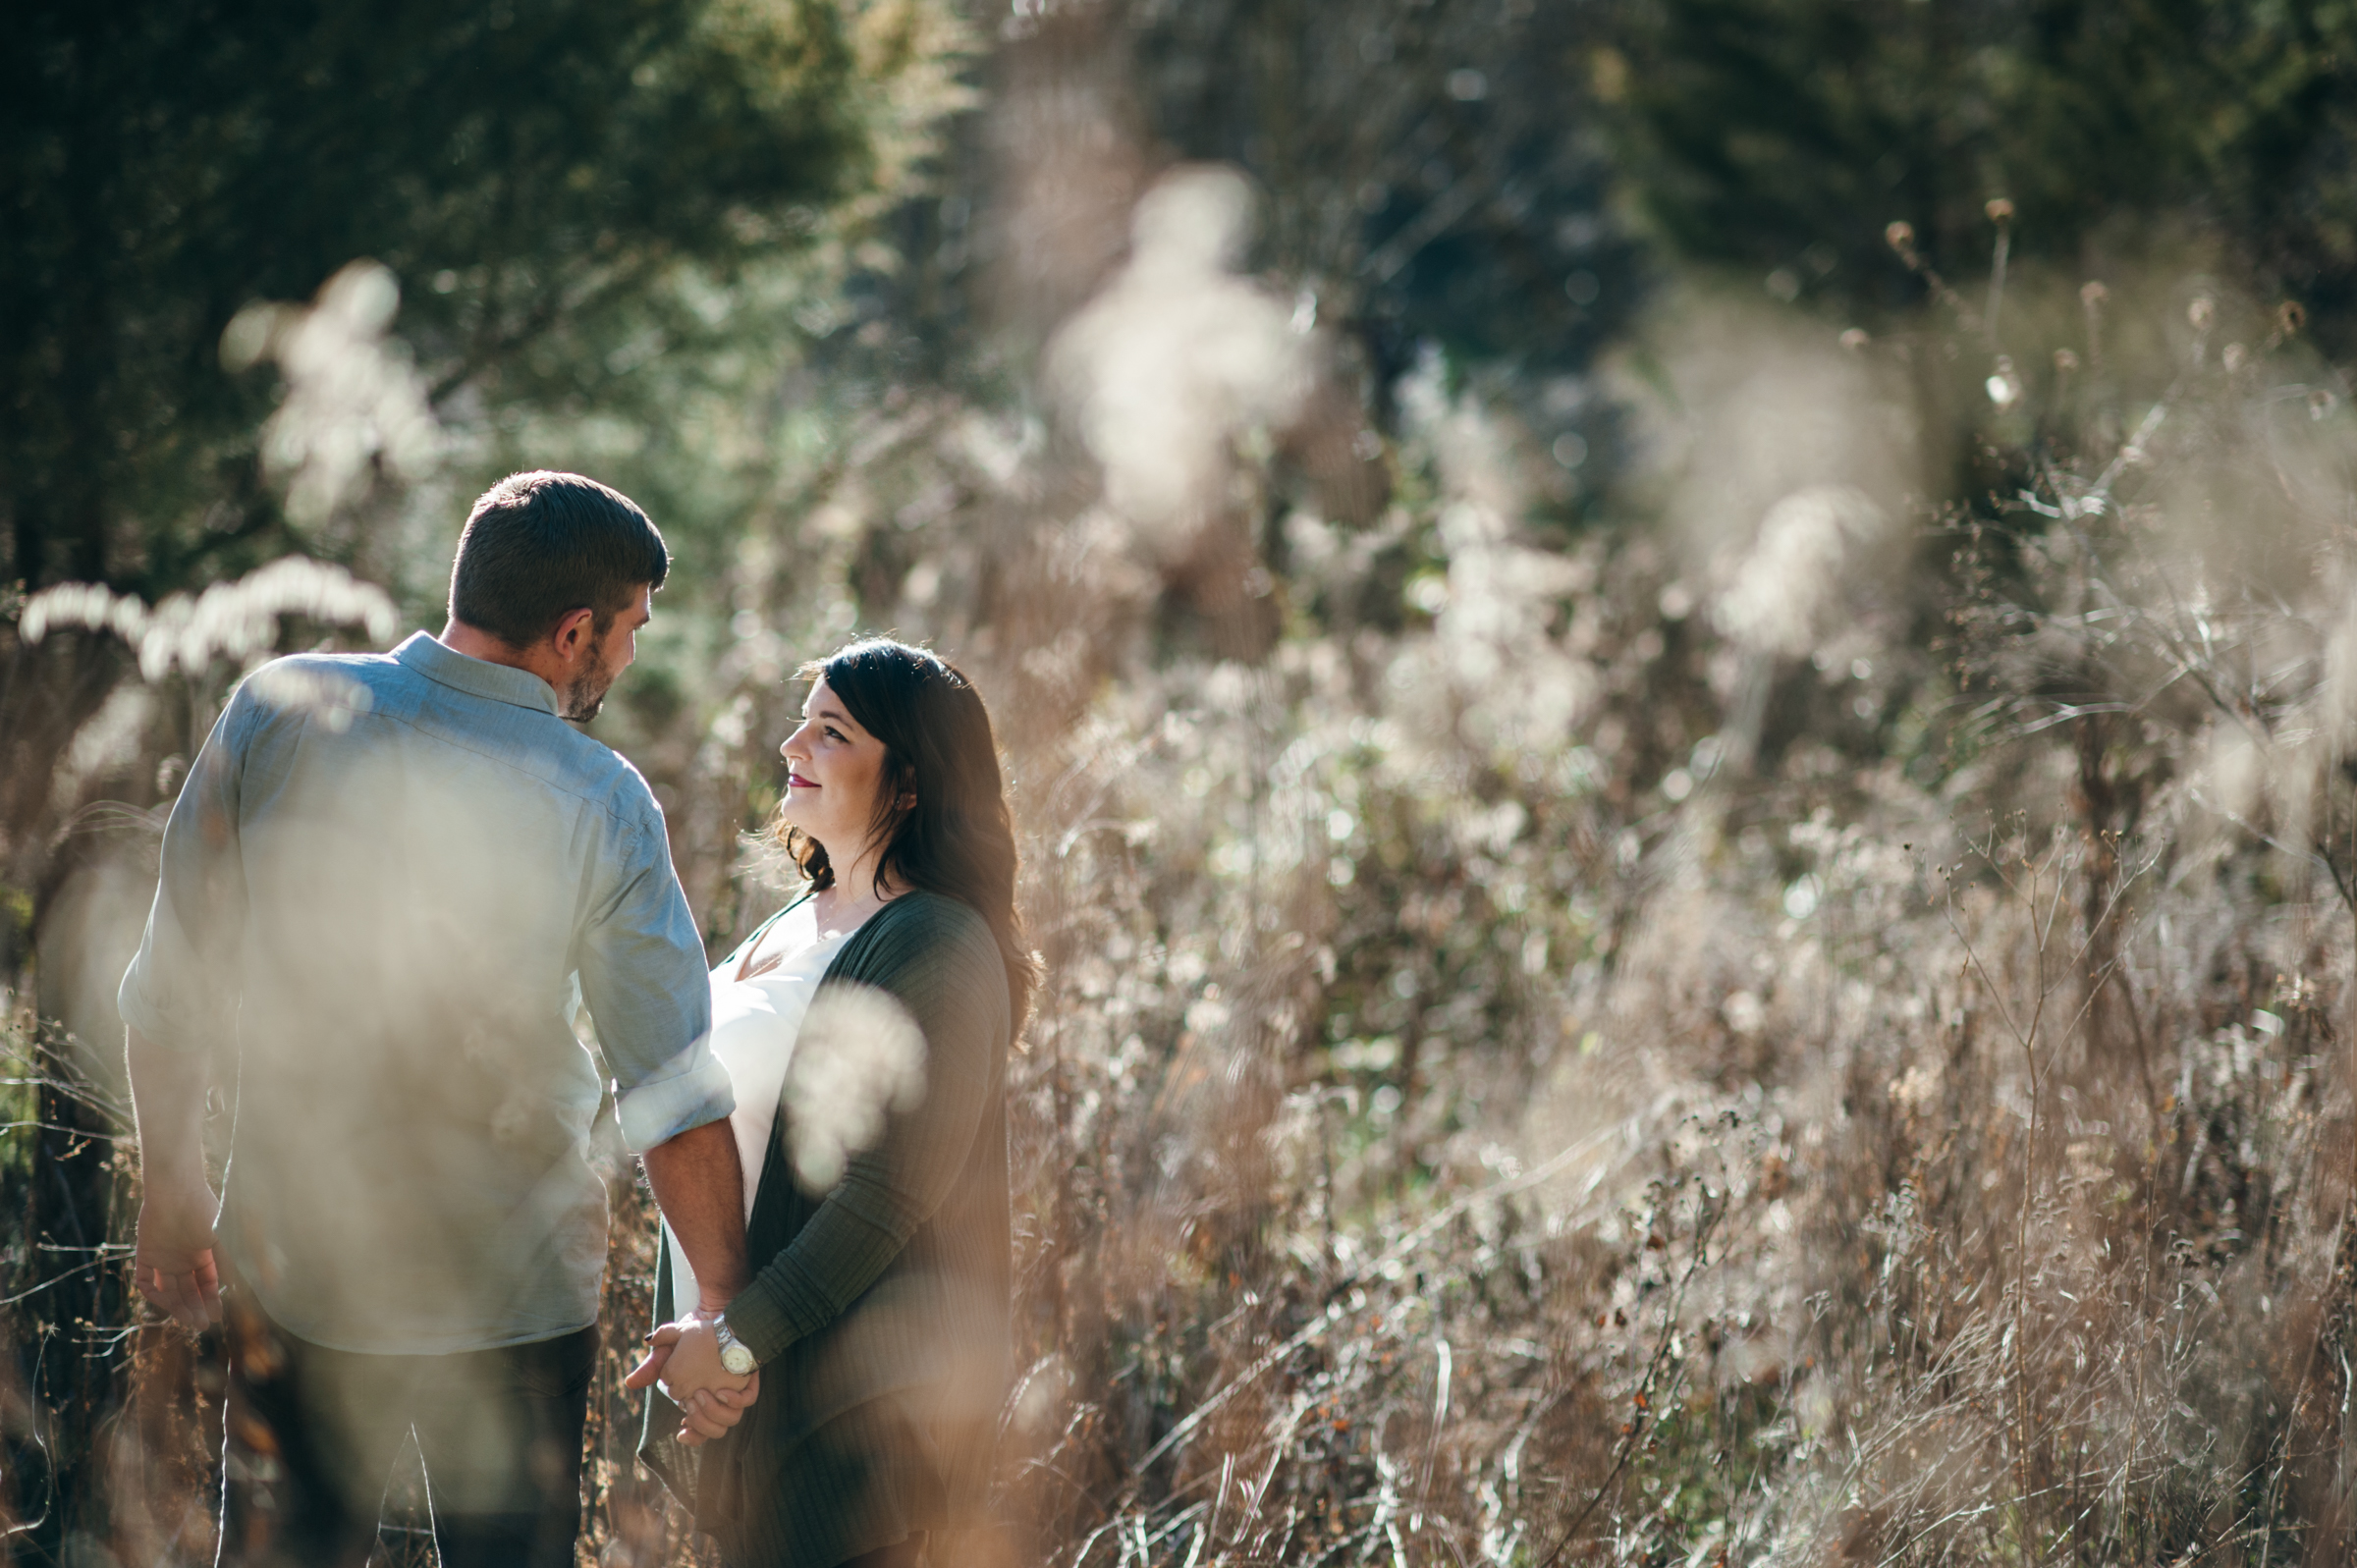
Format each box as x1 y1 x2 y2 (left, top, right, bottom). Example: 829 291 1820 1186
662 898 865 1314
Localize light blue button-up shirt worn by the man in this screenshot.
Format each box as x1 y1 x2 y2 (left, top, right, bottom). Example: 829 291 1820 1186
120 632 733 1353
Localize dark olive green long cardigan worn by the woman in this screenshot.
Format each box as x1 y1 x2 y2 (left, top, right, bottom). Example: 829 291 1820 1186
638 892 1012 1568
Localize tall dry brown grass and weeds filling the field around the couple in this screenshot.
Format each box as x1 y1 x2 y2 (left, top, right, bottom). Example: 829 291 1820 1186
0 198 2357 1568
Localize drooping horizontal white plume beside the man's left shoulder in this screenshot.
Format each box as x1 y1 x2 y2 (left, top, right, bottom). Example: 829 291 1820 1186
17 557 401 681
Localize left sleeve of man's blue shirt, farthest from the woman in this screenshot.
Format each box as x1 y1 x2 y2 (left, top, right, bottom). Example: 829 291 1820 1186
116 686 254 1052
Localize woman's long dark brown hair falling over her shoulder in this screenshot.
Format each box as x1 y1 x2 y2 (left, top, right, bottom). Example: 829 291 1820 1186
783 636 1039 1035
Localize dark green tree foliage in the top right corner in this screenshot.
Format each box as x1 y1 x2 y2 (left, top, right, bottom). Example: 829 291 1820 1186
1603 0 2357 342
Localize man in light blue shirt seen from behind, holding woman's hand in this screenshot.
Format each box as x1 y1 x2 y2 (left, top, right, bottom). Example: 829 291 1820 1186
120 474 744 1568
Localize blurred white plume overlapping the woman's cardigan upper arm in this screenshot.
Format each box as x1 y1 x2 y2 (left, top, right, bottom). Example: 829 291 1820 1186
783 986 924 1193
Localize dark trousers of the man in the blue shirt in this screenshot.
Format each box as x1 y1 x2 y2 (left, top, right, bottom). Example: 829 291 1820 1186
222 1292 599 1568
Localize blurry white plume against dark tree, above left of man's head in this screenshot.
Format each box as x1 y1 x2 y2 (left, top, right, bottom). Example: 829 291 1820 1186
222 262 443 526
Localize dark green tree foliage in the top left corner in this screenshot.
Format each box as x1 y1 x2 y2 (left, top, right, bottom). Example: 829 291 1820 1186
0 0 872 594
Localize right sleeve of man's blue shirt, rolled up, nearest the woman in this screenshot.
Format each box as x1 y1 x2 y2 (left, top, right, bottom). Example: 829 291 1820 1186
579 797 736 1153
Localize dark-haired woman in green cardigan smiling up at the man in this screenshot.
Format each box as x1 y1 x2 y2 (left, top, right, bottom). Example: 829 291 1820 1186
631 639 1032 1568
